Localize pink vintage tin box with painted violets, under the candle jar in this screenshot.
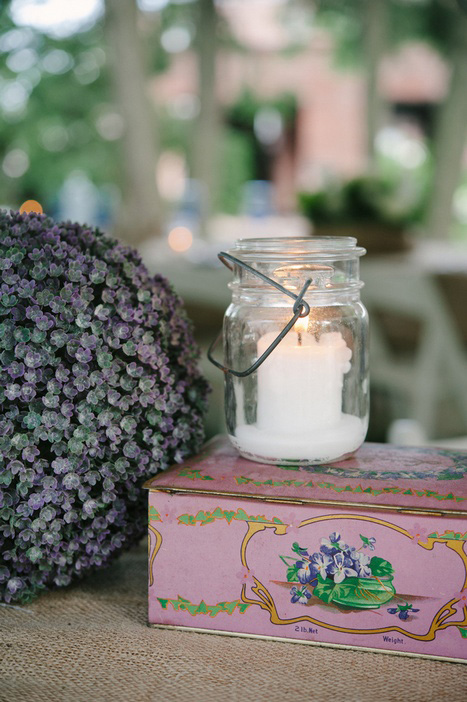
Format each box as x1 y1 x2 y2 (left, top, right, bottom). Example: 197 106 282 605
145 437 467 661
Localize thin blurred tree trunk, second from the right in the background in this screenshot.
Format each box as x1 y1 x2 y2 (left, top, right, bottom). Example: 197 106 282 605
363 0 389 171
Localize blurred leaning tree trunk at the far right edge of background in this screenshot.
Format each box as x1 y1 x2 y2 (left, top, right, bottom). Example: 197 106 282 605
426 10 467 239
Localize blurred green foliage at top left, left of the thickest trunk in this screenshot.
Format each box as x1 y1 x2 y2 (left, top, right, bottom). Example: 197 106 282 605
0 6 118 206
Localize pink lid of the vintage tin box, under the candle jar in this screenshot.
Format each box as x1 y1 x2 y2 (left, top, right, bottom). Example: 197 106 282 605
144 436 467 516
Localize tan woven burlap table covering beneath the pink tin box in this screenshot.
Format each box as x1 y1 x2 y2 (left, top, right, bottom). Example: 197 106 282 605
0 546 467 702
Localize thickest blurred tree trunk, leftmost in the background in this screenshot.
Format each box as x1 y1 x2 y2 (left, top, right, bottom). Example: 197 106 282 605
105 0 161 243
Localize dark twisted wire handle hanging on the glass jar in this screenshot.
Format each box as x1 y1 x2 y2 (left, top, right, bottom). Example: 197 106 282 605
207 251 313 378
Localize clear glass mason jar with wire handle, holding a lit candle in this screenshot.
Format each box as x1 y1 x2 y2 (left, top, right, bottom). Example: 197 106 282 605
223 237 369 465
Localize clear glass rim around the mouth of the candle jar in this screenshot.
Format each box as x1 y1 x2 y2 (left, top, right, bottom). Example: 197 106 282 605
230 236 366 259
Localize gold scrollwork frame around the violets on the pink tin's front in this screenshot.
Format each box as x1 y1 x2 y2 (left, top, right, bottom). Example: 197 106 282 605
241 514 467 641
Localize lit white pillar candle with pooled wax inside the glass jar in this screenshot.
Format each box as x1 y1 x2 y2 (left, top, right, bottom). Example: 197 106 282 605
236 318 366 463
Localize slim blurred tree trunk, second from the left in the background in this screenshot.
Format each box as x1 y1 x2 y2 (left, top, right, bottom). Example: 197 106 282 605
191 0 220 236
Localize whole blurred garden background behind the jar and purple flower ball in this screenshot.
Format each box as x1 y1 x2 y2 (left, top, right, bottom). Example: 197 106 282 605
0 0 467 448
